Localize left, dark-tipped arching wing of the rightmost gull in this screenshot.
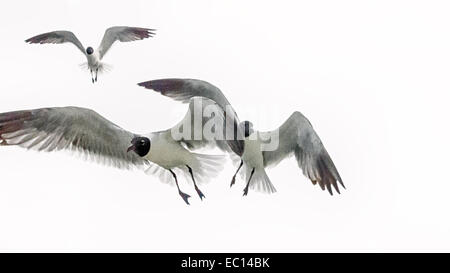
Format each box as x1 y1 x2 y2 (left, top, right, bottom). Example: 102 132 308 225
138 79 244 156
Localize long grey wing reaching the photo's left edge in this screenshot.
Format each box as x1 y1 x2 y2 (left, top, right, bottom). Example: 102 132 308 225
0 107 146 168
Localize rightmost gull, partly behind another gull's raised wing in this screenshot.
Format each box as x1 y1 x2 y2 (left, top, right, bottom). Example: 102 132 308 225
138 79 345 196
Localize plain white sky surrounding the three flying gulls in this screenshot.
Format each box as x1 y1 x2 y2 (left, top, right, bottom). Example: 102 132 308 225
0 0 450 251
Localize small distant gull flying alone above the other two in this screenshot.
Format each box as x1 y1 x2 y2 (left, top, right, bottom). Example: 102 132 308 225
25 26 156 83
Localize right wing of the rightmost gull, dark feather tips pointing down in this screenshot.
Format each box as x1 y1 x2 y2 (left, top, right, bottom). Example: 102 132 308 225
260 112 345 195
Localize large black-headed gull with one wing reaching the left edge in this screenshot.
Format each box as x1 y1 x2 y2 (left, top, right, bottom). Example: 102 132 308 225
0 98 226 205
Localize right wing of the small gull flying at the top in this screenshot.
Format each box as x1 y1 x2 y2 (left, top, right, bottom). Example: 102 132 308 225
98 27 156 59
